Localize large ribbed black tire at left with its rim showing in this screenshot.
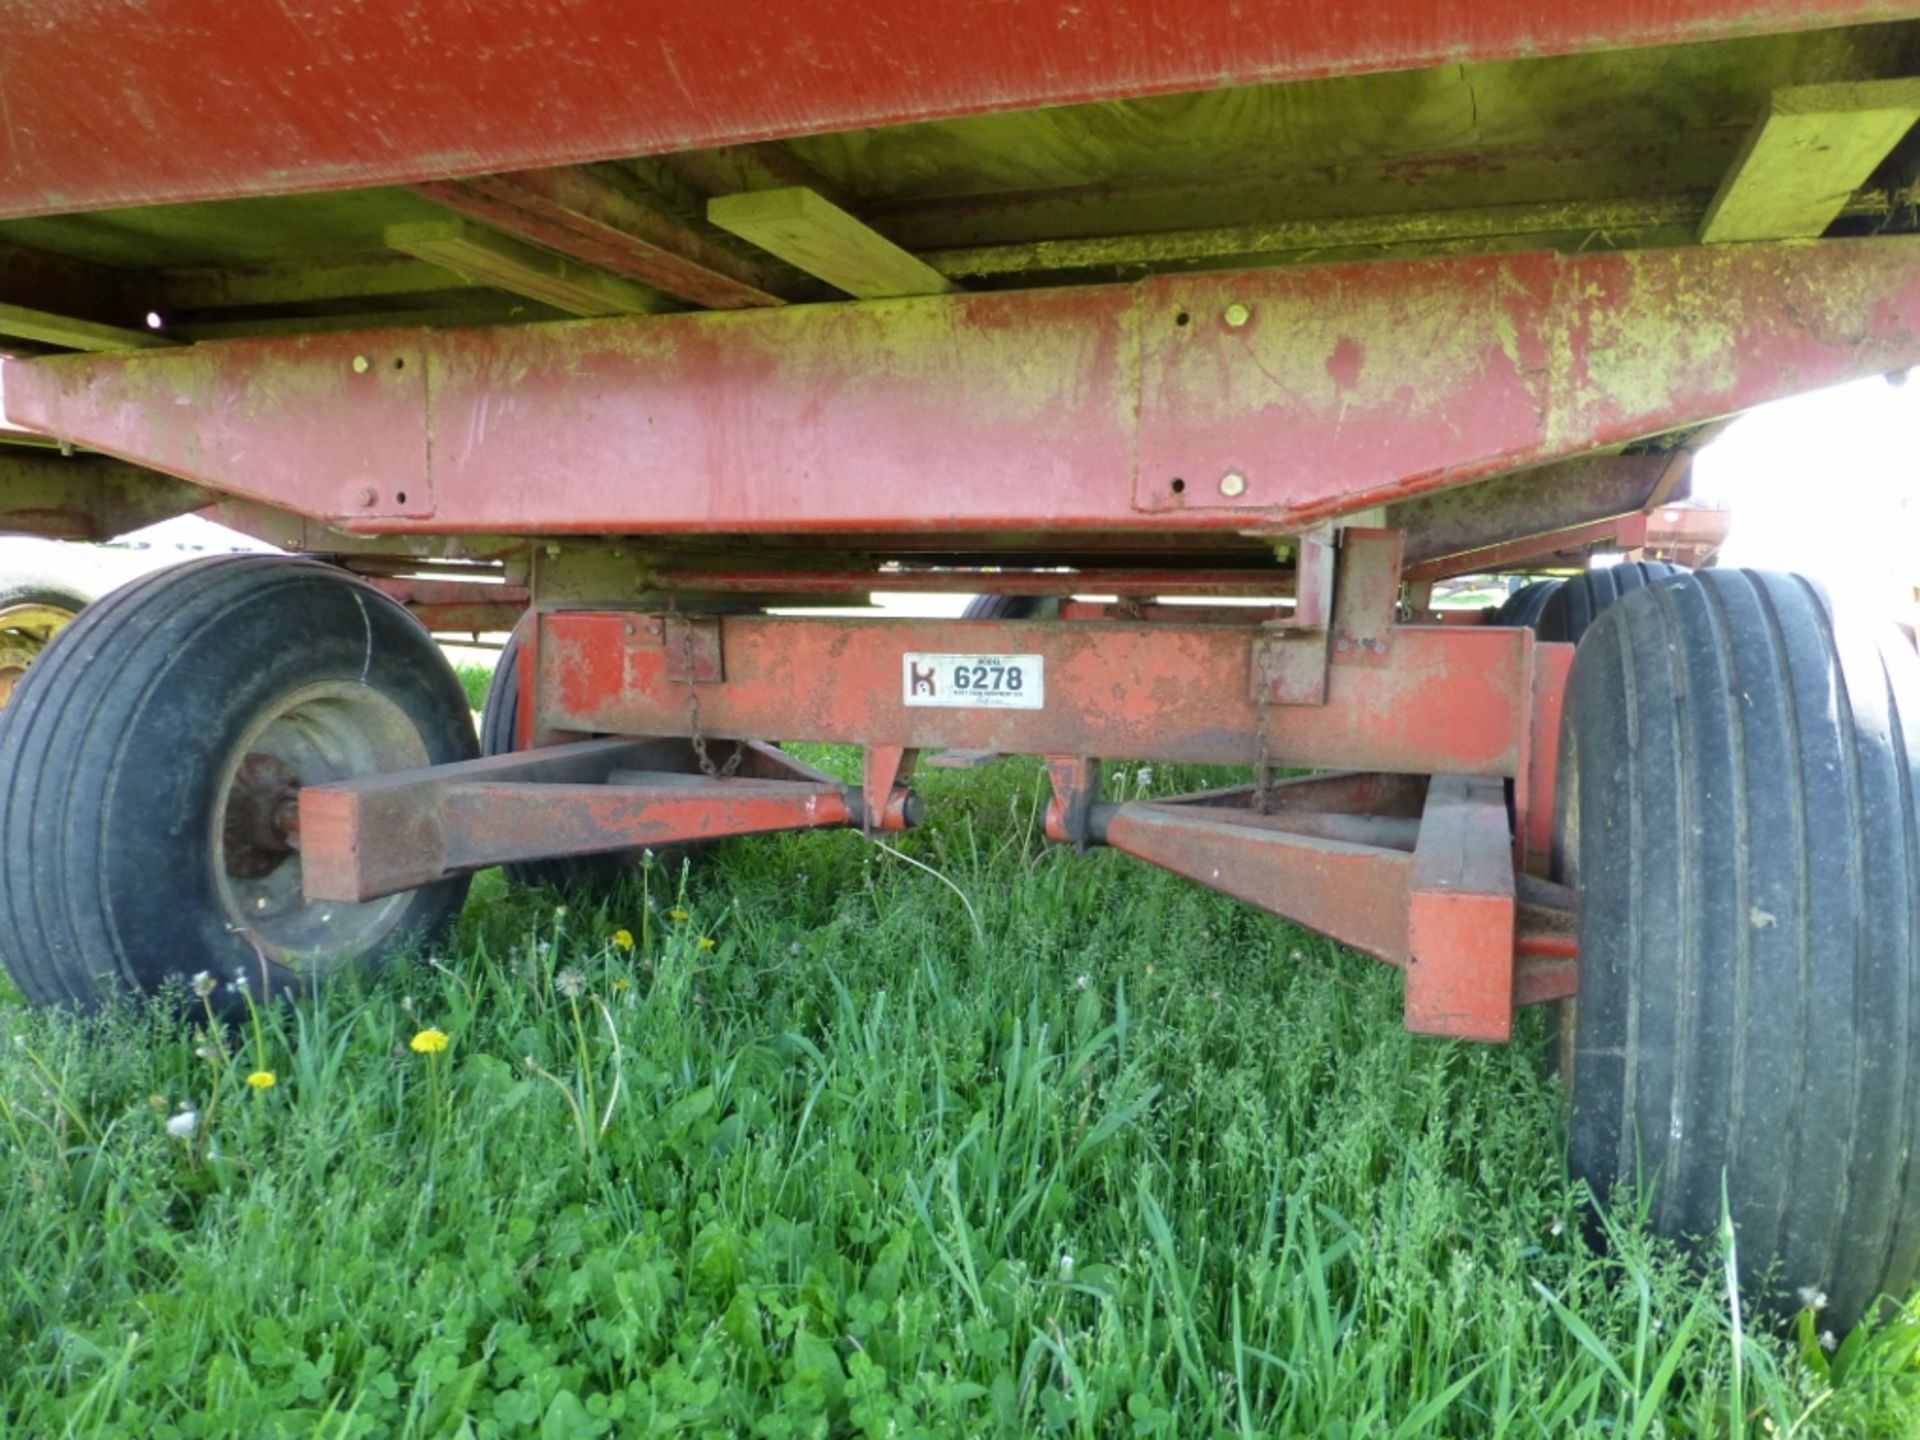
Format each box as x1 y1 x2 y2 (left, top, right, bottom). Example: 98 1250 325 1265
0 555 474 1008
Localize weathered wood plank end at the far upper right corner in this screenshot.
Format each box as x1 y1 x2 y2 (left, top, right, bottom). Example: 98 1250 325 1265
1699 79 1920 244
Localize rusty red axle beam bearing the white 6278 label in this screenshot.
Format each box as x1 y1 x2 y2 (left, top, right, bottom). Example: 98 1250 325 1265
522 611 1534 776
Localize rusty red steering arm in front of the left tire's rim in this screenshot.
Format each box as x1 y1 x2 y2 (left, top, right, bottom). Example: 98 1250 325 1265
300 741 860 902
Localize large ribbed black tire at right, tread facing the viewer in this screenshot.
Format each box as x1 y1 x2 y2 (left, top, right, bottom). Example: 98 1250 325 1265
1555 570 1920 1329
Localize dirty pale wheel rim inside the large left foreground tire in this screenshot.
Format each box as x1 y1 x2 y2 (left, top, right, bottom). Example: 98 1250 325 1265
211 682 430 968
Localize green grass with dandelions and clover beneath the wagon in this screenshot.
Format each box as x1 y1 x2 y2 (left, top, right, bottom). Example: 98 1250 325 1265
0 756 1920 1436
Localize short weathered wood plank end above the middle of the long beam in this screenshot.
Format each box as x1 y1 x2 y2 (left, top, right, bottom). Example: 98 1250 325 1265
707 186 960 300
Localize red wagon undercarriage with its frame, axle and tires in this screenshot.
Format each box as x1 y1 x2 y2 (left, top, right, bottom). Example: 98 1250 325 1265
0 0 1920 1313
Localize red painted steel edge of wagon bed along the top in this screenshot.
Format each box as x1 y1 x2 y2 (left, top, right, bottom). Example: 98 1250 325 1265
0 0 1916 217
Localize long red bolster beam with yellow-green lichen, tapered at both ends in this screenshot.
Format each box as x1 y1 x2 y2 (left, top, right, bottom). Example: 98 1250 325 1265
4 236 1920 543
